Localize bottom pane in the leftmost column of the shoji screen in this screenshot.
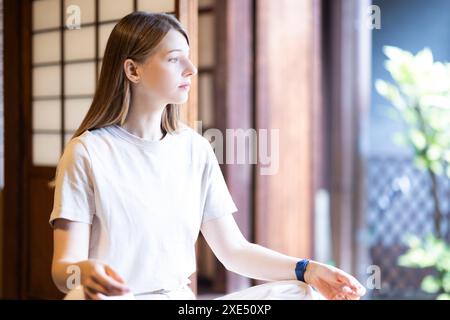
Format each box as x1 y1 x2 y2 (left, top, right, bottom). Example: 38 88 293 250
33 133 61 166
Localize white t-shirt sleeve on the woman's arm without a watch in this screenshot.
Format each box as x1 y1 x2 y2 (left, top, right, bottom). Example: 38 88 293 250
49 139 95 227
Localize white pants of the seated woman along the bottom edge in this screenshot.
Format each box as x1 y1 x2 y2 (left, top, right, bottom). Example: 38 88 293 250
64 280 324 300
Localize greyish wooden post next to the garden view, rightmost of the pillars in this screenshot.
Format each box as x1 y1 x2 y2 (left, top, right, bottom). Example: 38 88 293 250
325 0 371 277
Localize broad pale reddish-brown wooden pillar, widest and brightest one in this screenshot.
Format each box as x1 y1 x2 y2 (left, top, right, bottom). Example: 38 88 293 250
255 0 317 257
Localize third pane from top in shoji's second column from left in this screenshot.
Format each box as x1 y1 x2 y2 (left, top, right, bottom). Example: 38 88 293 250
64 62 95 95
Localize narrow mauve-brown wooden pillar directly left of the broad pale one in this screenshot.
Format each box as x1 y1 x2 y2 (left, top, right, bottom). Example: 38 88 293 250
214 0 253 292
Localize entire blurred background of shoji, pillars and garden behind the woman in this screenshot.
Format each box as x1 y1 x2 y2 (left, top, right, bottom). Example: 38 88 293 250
0 0 450 299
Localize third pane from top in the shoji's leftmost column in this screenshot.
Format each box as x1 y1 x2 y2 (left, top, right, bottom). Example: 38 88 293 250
33 66 61 97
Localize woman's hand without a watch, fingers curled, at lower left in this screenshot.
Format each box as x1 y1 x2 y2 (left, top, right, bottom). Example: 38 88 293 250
79 260 130 300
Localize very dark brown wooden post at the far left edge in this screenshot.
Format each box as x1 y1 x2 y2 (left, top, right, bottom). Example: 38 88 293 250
1 0 30 299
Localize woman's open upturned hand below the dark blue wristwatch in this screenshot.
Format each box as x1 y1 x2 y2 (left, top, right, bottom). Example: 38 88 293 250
304 260 366 300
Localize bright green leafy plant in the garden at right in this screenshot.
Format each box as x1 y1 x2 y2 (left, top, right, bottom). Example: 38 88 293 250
375 47 450 299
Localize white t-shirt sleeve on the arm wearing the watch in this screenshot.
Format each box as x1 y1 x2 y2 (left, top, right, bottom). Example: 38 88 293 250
202 140 238 223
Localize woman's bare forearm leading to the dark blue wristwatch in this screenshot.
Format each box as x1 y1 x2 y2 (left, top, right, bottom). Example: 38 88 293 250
223 242 300 281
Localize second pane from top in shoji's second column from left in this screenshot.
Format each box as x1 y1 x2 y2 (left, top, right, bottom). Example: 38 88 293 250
64 27 95 61
